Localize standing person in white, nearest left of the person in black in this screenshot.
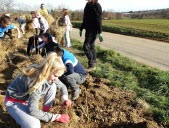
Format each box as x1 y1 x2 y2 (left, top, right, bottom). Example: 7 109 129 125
63 9 72 47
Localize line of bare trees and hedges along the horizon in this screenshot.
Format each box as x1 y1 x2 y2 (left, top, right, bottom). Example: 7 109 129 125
0 0 169 21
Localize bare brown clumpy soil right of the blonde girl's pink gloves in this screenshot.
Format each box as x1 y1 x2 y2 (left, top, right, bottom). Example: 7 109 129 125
39 75 162 128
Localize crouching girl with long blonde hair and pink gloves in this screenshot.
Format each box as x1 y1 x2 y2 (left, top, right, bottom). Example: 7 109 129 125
5 52 71 128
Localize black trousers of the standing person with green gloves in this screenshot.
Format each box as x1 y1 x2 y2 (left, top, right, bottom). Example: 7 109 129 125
83 30 97 67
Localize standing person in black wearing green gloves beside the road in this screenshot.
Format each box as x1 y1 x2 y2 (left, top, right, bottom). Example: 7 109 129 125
80 0 103 71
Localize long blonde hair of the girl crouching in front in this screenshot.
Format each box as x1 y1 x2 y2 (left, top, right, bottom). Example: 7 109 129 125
21 52 66 94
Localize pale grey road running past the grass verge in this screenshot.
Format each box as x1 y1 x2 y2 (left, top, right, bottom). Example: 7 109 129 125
71 28 169 70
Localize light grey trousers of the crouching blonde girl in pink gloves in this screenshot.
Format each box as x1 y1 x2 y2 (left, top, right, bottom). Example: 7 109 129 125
5 84 56 128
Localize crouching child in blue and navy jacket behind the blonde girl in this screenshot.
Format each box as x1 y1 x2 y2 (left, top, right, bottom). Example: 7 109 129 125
54 47 86 100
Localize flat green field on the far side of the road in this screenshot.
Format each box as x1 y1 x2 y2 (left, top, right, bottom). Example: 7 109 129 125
73 19 169 42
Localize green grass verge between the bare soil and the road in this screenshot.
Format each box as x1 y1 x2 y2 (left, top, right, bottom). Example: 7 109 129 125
73 39 169 124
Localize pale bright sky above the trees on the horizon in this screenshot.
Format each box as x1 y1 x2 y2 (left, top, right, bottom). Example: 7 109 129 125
14 0 169 12
